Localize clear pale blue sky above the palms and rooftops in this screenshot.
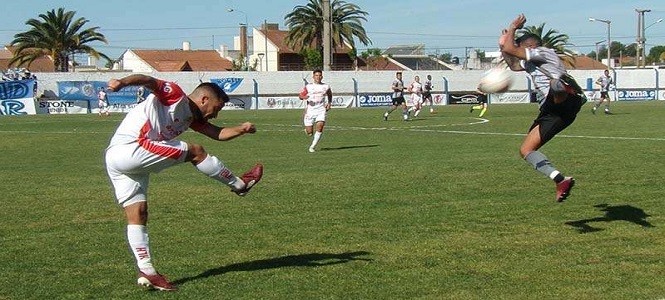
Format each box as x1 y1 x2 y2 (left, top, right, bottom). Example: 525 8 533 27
0 0 665 61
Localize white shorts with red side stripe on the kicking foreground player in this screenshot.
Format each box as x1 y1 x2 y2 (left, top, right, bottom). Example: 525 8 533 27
106 140 188 207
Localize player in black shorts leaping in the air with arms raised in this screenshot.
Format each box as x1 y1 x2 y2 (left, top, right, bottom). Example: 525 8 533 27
499 14 586 202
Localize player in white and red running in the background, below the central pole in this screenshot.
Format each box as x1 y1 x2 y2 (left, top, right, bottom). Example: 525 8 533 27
299 70 332 152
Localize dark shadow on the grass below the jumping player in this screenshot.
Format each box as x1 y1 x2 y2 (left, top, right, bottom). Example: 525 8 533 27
565 204 655 233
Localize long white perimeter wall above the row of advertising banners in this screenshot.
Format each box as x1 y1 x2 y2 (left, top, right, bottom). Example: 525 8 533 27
36 69 665 96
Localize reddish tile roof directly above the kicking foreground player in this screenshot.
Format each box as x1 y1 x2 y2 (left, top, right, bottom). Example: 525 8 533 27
131 50 233 72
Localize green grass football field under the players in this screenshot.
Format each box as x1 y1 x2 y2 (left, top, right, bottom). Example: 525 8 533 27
0 101 665 299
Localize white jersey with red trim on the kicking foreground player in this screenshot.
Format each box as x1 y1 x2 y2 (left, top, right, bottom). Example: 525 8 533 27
109 80 205 150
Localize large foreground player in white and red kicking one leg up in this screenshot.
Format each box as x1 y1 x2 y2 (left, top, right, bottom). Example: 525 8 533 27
106 75 263 291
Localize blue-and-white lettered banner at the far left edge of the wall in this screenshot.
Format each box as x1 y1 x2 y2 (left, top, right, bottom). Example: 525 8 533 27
0 79 36 115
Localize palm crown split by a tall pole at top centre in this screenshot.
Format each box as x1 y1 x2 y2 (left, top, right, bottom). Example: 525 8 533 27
284 0 372 50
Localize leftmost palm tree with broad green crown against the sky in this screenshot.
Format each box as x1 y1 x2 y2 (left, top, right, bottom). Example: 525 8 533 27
9 8 110 72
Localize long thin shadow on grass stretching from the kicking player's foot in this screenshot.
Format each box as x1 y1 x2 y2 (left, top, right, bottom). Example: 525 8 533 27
172 251 372 284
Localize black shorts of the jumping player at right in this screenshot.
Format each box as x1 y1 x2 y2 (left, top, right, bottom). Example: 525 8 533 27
529 93 586 146
